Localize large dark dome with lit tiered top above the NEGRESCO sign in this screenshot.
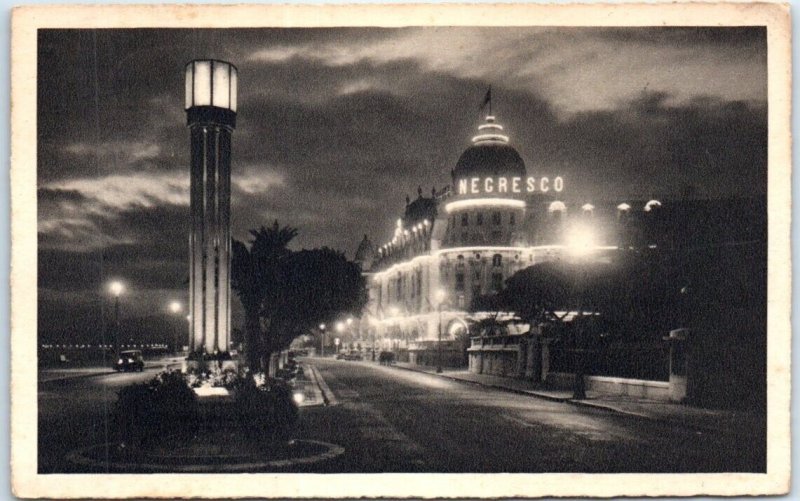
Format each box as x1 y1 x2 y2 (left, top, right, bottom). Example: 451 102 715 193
453 116 527 180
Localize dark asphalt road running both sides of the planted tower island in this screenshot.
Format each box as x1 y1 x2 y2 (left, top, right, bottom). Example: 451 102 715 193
39 359 764 473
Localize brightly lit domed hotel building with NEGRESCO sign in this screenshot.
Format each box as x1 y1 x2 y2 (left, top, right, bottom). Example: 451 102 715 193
355 116 661 375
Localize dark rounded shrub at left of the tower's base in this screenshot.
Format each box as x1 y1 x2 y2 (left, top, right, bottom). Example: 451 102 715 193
113 371 199 447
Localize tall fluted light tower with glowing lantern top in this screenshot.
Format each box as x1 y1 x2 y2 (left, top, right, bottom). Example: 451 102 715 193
186 60 237 354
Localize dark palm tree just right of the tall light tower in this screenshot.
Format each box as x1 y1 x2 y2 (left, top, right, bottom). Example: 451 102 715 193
231 221 297 371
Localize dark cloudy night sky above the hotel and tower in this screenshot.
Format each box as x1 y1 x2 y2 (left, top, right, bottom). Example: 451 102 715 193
38 28 767 340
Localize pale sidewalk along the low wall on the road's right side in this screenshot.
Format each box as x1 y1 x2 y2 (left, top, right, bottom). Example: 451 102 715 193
394 362 766 433
